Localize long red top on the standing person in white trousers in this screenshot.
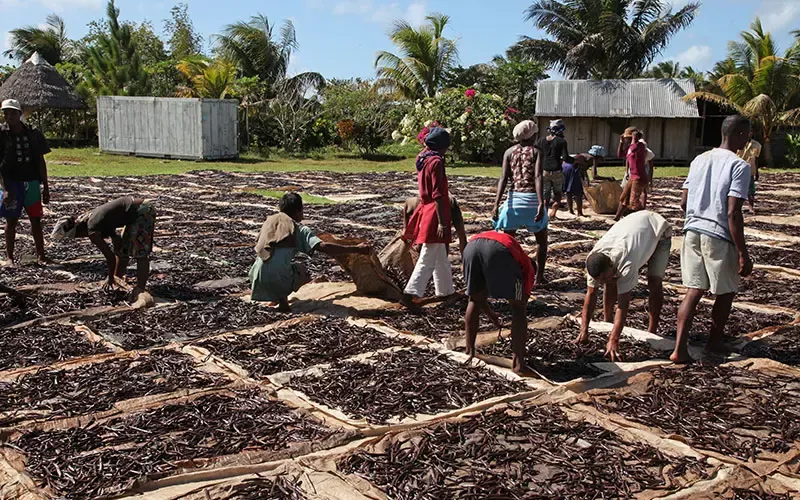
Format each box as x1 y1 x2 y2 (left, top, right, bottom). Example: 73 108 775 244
403 152 452 245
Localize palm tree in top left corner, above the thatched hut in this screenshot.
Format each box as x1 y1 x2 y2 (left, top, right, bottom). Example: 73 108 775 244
3 14 72 66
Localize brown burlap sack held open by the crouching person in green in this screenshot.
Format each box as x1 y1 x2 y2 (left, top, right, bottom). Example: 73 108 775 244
319 234 403 301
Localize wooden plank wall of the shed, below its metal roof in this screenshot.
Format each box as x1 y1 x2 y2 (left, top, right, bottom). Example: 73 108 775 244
538 117 697 162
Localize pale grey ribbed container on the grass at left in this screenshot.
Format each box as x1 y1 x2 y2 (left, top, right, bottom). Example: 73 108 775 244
97 96 239 160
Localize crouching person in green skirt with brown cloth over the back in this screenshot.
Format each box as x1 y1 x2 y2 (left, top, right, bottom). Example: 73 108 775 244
248 193 372 312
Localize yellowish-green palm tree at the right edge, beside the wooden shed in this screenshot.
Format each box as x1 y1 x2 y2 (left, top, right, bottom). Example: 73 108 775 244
684 18 800 165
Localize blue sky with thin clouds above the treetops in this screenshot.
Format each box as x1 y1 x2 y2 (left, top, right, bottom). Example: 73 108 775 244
0 0 800 78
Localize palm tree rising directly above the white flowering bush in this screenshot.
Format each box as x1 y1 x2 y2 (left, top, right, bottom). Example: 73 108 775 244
375 14 458 99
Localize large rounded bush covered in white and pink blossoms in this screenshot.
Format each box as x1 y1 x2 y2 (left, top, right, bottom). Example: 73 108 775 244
392 89 519 159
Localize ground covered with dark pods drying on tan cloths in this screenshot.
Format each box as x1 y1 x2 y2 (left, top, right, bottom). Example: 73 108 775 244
0 171 800 499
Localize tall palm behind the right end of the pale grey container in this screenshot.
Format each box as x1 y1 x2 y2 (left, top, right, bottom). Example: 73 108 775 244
216 14 297 85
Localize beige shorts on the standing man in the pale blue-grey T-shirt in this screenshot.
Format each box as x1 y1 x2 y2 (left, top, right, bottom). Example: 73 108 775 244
681 231 739 295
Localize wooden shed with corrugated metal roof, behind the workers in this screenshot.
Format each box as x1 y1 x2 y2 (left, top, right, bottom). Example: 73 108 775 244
536 79 700 163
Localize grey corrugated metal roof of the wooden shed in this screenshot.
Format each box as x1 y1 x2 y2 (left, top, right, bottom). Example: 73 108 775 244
536 79 700 118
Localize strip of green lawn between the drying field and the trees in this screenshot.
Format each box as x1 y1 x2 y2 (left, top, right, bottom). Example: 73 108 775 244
47 146 689 179
